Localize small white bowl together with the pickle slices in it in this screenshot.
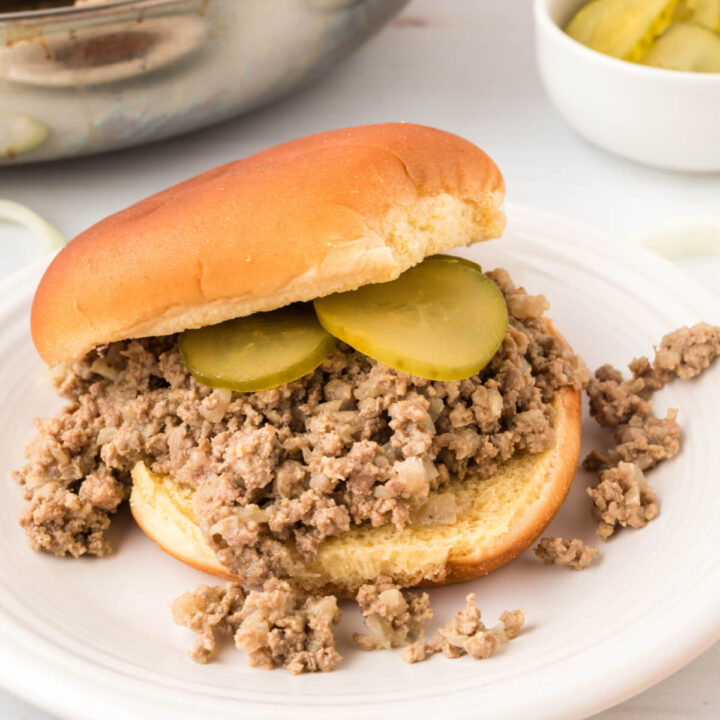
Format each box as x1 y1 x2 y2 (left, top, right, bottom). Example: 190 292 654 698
535 0 720 172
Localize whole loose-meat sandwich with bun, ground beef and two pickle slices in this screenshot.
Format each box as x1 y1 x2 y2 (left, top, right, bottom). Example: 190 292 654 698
17 123 587 596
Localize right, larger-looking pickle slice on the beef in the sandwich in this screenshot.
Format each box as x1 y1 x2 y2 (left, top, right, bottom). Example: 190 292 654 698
315 255 508 380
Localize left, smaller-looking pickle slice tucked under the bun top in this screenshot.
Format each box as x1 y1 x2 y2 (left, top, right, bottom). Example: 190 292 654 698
178 304 336 392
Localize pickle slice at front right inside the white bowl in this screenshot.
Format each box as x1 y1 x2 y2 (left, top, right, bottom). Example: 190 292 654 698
644 23 720 73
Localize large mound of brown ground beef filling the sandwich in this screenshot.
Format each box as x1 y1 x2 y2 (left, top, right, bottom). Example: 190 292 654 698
17 270 587 585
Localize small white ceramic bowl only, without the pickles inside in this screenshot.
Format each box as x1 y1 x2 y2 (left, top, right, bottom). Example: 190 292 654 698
535 0 720 171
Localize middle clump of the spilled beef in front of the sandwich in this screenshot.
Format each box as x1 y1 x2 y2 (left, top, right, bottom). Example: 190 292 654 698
353 575 433 650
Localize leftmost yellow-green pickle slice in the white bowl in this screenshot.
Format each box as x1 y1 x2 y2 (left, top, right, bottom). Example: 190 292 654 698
566 0 678 62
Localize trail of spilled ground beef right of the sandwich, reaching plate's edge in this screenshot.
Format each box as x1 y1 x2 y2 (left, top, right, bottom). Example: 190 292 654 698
583 323 720 540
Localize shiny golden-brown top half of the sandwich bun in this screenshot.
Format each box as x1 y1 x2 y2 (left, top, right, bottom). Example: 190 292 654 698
32 123 505 365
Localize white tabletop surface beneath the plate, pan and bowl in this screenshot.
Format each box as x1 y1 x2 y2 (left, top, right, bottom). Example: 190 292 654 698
0 0 720 720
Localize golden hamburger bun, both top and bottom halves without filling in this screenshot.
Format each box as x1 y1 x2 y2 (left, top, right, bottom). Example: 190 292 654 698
32 123 580 595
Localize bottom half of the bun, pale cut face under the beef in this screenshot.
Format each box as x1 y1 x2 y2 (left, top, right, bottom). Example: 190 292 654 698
130 388 581 596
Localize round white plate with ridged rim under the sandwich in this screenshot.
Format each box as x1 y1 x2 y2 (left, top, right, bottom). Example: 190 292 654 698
0 207 720 720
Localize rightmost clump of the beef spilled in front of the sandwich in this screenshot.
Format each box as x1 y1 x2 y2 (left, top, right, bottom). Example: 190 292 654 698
402 593 525 663
